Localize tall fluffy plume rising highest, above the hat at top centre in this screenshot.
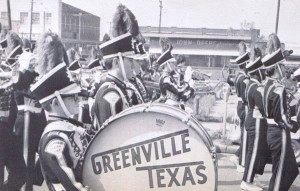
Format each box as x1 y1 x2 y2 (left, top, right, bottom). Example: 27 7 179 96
111 4 145 43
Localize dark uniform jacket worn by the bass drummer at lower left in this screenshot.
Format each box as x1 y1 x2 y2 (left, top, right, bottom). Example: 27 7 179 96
39 121 87 191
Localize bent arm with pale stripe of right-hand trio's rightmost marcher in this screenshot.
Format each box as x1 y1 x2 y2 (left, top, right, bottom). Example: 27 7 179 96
274 87 299 132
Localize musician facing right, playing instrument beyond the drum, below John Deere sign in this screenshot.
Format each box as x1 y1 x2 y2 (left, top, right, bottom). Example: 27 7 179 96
157 46 195 109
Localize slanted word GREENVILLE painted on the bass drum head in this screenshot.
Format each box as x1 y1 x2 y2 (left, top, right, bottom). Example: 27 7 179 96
91 129 191 174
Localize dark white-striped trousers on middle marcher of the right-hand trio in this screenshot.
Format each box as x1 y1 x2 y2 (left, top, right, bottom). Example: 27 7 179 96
243 119 270 183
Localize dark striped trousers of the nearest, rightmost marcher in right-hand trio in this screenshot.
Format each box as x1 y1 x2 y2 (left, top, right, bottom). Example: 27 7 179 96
267 124 299 191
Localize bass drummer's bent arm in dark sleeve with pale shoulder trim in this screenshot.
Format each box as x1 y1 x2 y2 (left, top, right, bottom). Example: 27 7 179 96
43 138 86 191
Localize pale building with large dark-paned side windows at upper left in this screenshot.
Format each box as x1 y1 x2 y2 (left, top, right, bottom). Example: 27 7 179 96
0 0 100 53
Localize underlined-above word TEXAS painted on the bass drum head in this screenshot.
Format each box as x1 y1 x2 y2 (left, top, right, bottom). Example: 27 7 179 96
136 161 207 188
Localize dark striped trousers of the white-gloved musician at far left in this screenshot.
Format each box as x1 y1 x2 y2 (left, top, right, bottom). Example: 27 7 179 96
14 111 46 190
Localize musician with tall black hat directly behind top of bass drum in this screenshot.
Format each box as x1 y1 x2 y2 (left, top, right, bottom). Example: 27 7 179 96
92 33 136 127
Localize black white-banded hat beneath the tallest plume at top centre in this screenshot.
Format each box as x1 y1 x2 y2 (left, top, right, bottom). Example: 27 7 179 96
100 33 134 59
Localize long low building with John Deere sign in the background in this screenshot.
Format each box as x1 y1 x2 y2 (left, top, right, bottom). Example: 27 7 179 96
140 26 260 67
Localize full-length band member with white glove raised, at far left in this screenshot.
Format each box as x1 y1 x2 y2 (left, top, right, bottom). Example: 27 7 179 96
7 33 46 190
